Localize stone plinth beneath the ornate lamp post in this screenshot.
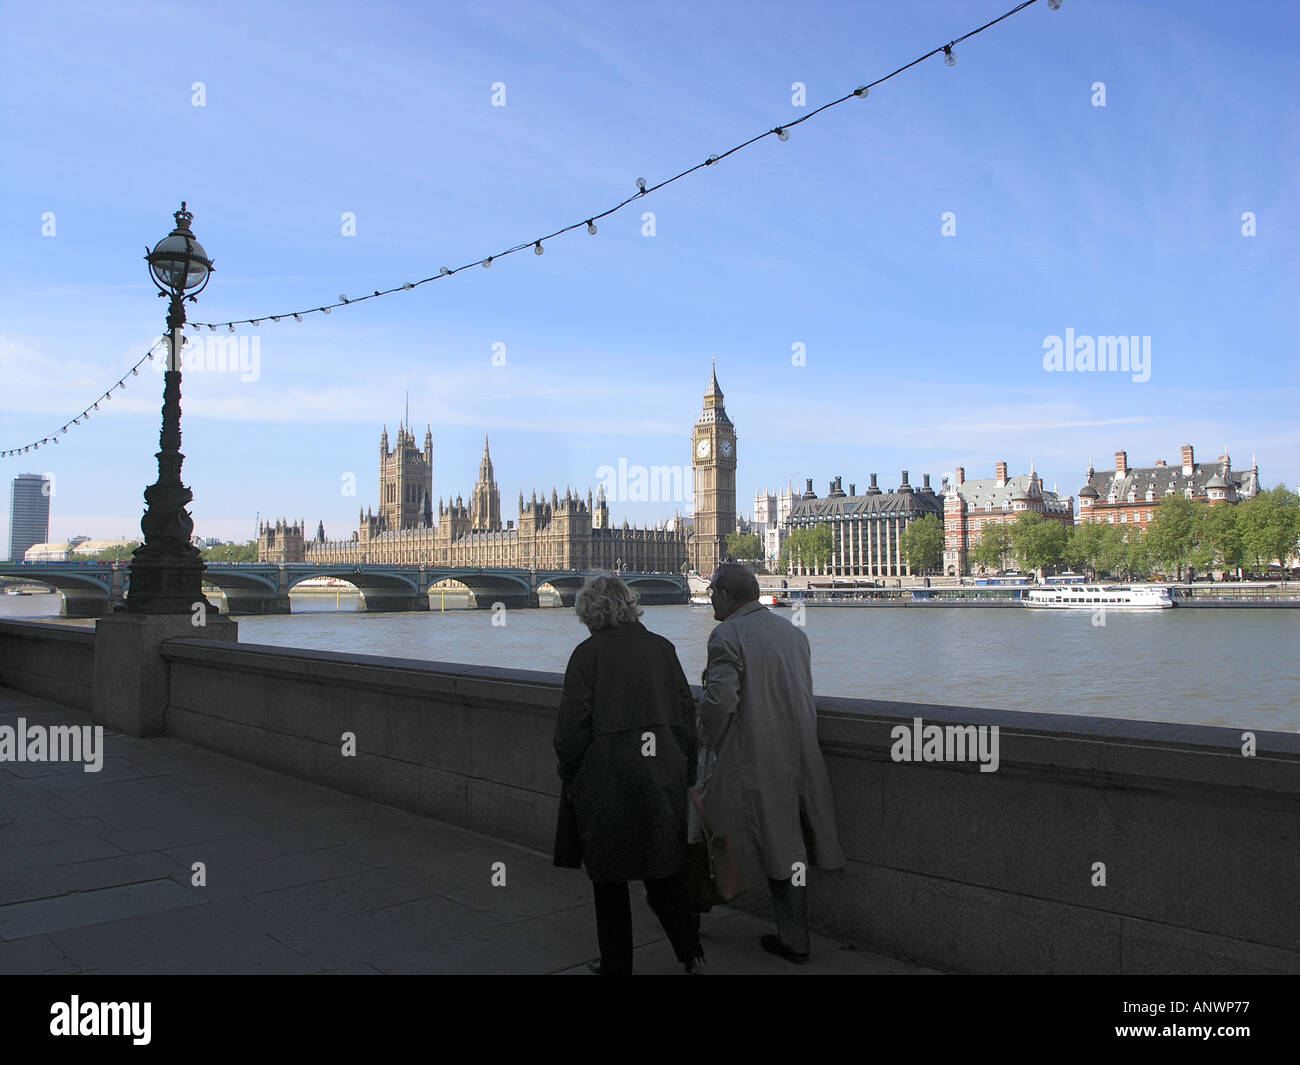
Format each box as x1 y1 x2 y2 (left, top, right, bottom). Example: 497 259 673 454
92 612 239 736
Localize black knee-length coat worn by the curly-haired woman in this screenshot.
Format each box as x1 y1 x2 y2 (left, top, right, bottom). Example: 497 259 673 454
555 622 698 882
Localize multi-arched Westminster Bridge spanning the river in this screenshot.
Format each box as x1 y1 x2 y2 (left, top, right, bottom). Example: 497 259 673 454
0 562 690 618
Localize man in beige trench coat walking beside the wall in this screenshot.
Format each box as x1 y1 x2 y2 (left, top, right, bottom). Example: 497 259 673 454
699 563 845 964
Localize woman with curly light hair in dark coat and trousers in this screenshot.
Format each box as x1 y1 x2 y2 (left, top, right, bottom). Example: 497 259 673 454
555 571 703 975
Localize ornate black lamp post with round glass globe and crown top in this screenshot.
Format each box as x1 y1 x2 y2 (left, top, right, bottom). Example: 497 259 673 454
126 202 217 614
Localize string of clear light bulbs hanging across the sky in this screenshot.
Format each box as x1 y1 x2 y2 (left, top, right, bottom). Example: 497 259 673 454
0 0 1061 458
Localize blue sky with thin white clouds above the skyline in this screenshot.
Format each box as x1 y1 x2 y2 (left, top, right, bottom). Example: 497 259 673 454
0 0 1300 540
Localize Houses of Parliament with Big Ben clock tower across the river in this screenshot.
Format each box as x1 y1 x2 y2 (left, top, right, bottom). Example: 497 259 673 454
257 368 736 573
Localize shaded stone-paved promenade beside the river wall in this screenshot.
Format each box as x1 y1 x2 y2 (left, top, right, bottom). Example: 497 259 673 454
0 688 932 975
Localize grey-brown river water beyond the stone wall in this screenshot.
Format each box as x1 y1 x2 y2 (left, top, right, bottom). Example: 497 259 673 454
0 596 1300 732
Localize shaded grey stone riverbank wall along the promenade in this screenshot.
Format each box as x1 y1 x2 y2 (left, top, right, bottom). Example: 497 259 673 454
0 622 1300 973
